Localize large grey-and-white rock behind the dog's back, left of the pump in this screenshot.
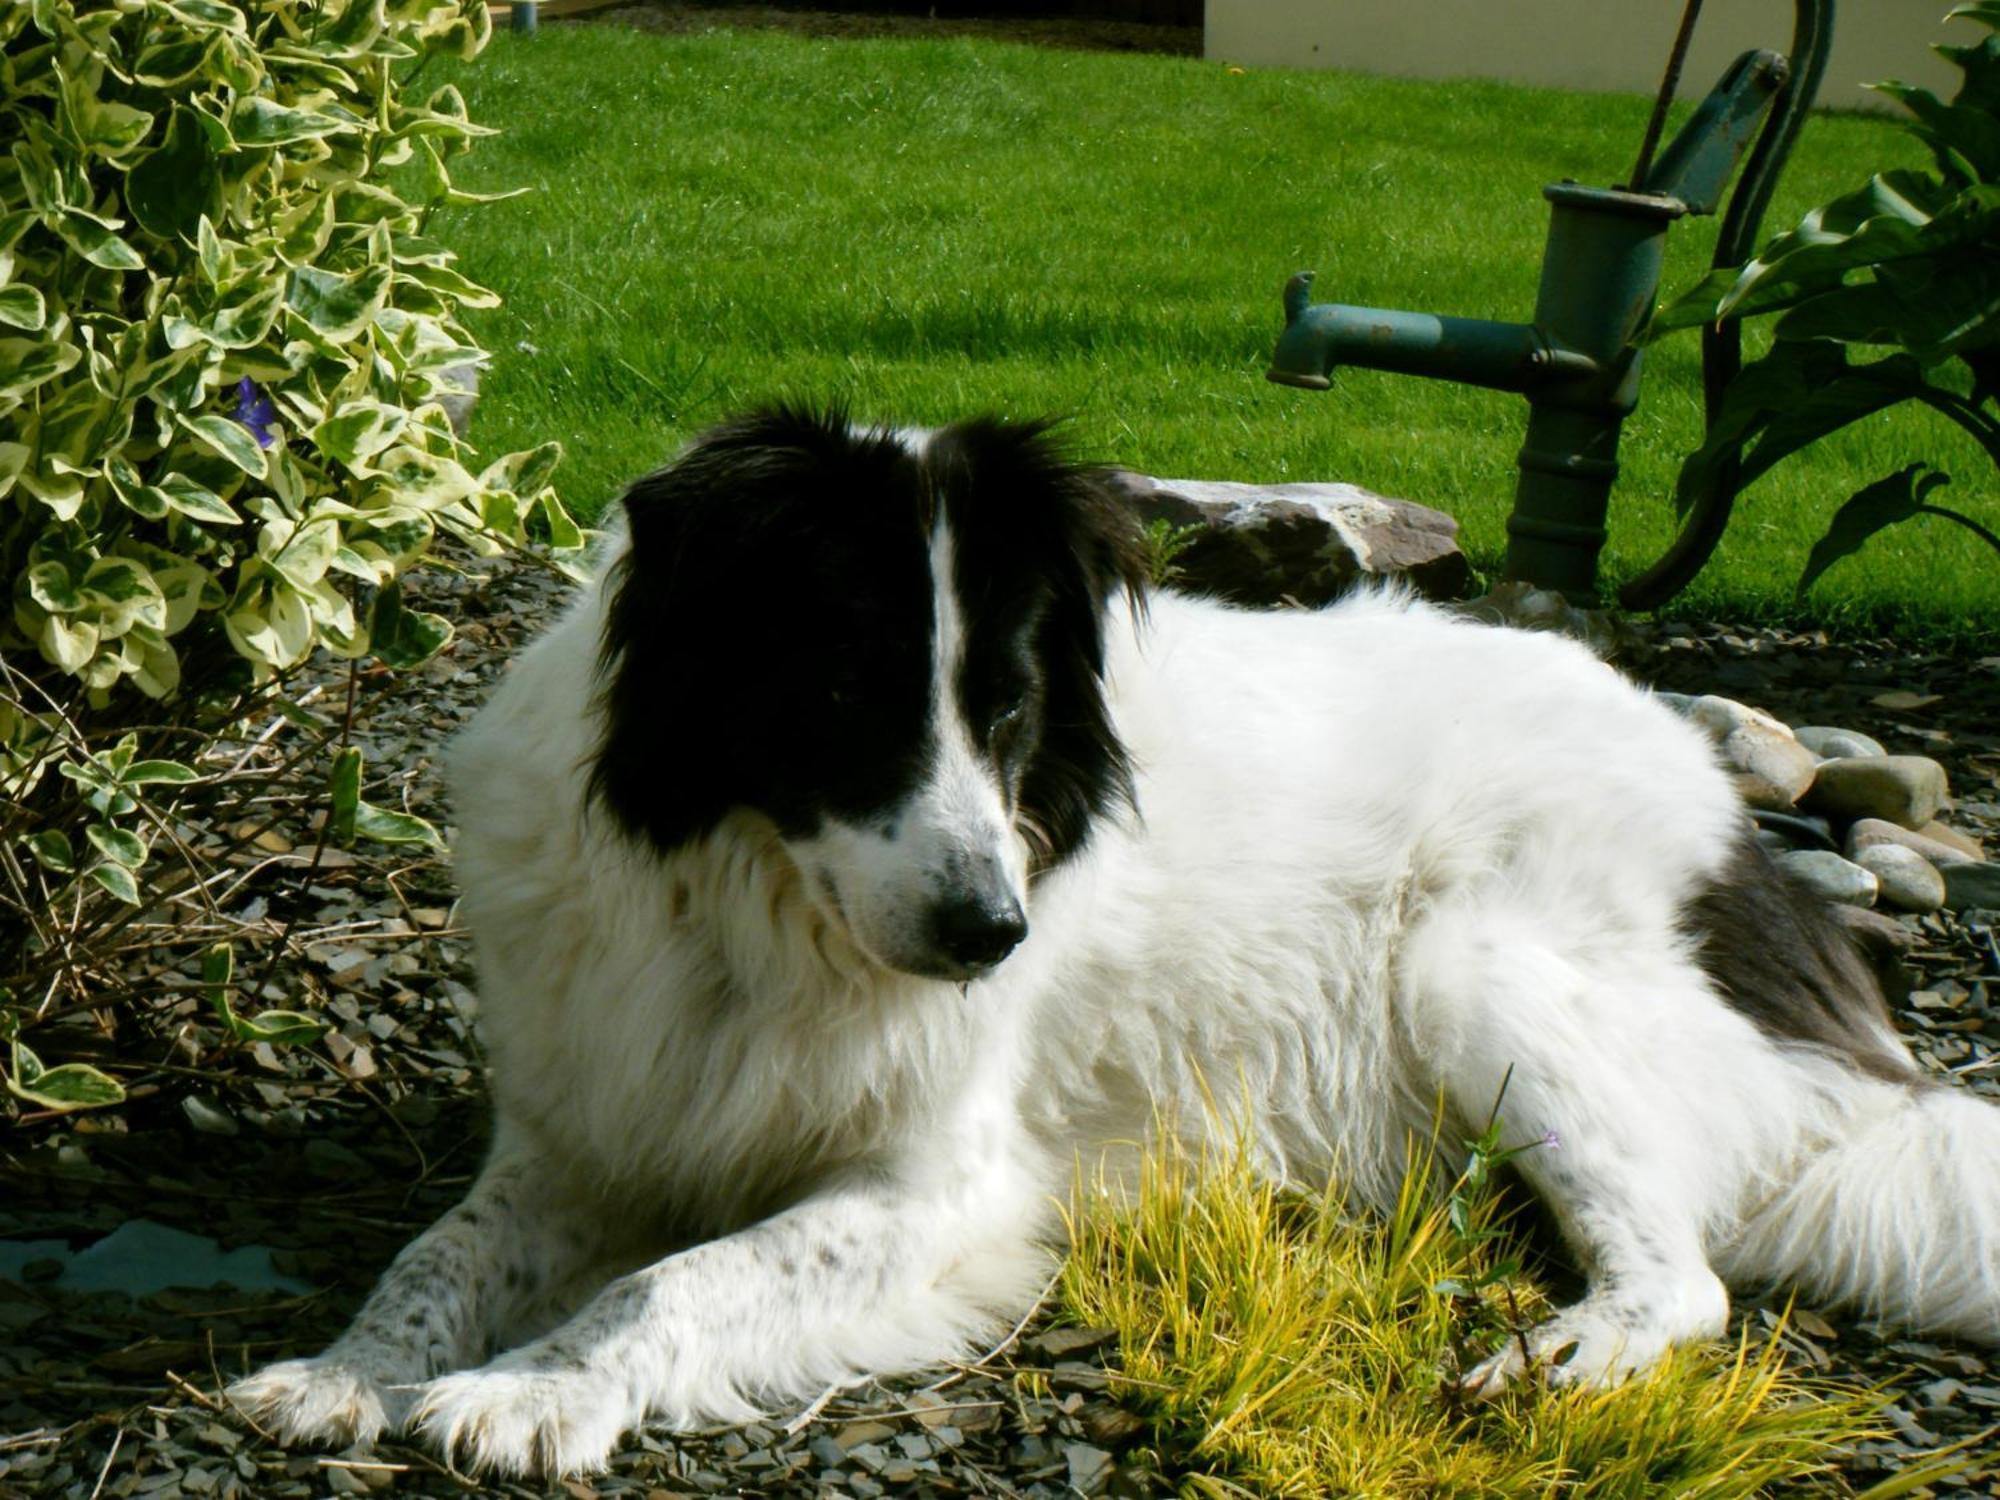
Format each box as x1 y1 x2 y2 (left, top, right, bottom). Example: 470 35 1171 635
1116 472 1472 606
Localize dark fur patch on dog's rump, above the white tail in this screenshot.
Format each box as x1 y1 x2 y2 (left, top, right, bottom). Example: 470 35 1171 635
1686 832 1918 1082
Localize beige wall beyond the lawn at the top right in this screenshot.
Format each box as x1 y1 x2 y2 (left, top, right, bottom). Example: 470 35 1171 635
1206 0 1960 108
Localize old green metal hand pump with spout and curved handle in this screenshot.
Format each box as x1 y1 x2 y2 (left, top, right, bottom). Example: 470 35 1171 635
1268 0 1834 608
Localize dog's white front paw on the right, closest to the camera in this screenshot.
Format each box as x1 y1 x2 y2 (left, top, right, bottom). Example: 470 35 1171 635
412 1360 624 1478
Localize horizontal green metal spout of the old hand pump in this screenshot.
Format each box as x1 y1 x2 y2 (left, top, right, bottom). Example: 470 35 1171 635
1264 270 1596 392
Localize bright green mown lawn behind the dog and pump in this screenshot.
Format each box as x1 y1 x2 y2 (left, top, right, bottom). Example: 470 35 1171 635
434 24 2000 636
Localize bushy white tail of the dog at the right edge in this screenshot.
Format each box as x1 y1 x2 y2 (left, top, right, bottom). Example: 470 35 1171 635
1722 1064 2000 1344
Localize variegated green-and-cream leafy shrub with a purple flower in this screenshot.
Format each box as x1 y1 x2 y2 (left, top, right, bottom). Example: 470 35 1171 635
0 0 582 1102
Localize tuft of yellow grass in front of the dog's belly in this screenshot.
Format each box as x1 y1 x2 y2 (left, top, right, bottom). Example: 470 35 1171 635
1060 1130 1906 1500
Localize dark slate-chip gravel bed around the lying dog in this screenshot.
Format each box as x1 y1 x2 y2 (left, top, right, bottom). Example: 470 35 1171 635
0 564 2000 1500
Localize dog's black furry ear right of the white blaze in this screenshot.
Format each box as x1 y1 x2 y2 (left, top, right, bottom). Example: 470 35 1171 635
928 418 1146 868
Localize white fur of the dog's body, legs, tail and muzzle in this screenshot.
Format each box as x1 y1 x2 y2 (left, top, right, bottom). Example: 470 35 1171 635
234 468 2000 1472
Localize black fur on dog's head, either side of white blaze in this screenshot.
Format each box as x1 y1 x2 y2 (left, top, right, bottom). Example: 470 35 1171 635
590 408 1144 868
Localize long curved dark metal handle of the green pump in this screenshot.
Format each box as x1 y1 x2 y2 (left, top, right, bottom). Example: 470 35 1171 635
1618 0 1834 610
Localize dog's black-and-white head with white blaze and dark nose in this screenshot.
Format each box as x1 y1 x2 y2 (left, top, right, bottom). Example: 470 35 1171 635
592 410 1144 980
